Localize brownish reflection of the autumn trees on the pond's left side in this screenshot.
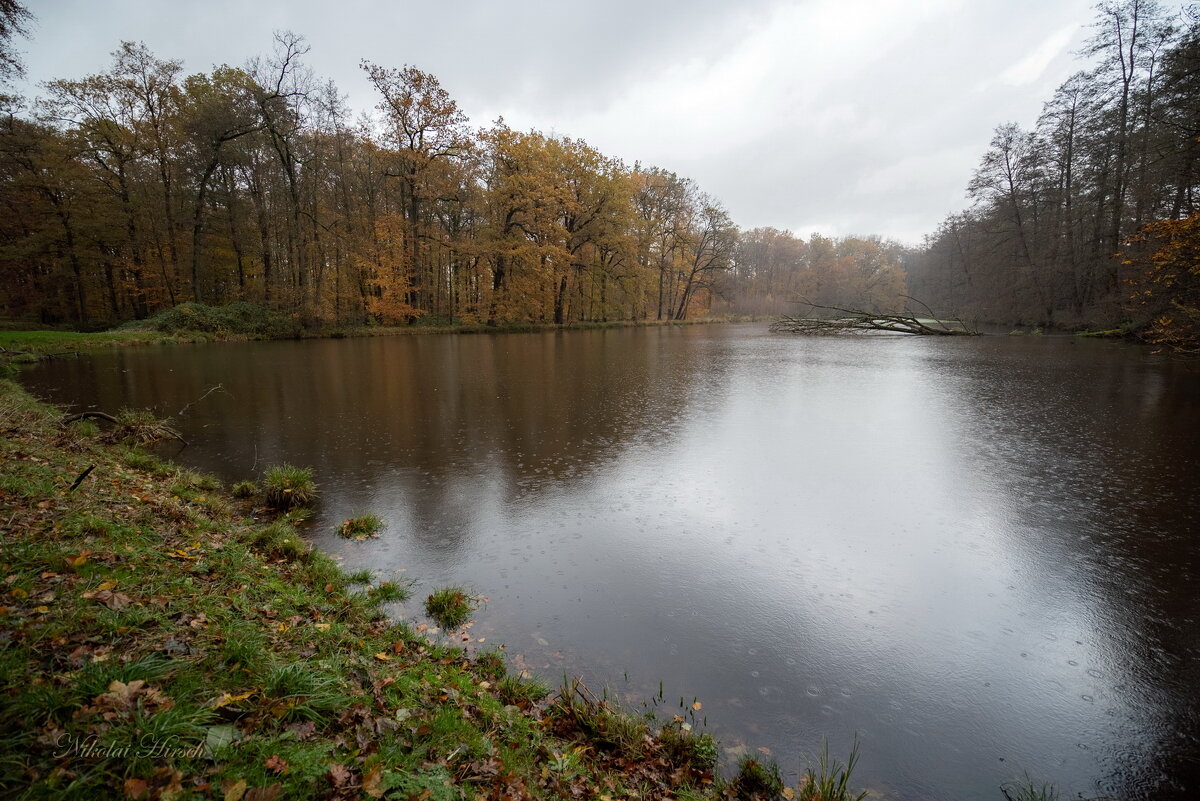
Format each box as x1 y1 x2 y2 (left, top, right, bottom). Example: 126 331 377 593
23 327 721 556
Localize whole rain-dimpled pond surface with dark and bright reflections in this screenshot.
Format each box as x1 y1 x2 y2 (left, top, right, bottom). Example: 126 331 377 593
21 326 1200 799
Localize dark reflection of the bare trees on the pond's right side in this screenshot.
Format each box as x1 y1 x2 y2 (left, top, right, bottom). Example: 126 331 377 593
947 342 1200 797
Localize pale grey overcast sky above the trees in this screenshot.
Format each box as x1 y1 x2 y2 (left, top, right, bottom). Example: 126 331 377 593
16 0 1093 243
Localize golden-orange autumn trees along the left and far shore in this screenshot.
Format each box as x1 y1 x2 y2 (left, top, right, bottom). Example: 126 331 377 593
0 27 904 327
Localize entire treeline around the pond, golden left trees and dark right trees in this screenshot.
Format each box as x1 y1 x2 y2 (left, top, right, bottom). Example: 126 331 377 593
0 0 1200 342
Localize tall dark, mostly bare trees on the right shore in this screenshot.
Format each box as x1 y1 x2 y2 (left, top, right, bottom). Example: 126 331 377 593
906 0 1200 335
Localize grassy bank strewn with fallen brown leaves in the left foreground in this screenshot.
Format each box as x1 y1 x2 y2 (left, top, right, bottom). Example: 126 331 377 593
0 380 816 800
